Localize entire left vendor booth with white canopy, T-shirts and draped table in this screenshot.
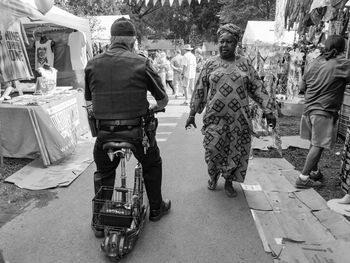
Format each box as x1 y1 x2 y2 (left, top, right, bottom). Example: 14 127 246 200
0 0 92 166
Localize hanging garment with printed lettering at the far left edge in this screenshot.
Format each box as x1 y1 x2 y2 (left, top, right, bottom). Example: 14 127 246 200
0 22 33 82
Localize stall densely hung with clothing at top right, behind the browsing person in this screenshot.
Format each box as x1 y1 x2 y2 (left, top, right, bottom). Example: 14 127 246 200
276 0 350 138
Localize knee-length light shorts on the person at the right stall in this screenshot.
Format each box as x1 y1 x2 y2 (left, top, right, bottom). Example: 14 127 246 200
300 115 338 149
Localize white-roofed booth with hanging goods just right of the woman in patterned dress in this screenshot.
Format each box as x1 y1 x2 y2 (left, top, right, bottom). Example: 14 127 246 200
242 21 303 116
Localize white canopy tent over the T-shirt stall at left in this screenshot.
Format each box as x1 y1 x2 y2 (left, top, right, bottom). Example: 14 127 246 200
0 0 93 87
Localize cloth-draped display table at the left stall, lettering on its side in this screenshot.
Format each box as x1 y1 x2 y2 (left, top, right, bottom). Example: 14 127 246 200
0 91 88 166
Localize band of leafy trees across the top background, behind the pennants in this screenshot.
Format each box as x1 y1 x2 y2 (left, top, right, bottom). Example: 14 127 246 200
55 0 276 45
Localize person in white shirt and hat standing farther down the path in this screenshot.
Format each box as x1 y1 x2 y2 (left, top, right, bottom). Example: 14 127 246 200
181 45 197 105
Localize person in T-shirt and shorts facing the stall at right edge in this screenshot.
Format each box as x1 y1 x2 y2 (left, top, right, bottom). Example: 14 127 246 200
295 35 350 188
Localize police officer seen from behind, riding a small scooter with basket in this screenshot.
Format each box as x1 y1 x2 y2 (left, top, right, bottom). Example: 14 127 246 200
85 18 171 237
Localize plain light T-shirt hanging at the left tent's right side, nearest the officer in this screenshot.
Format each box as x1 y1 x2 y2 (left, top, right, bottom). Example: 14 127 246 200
68 31 87 70
